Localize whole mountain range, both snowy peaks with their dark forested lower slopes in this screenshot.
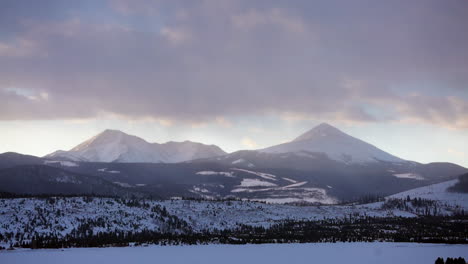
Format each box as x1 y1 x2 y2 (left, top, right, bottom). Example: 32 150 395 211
0 123 468 204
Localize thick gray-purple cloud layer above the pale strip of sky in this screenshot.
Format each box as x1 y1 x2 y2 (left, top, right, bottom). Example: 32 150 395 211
0 0 468 128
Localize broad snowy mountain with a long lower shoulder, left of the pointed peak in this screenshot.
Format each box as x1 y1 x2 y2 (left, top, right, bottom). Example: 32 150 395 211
45 129 226 163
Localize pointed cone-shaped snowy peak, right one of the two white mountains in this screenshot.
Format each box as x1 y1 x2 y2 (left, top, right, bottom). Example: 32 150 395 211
259 123 405 163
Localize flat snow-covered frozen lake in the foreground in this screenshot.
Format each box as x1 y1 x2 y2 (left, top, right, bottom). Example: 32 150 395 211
0 243 468 264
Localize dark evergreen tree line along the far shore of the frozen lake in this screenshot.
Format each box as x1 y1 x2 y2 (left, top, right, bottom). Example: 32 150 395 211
2 215 468 250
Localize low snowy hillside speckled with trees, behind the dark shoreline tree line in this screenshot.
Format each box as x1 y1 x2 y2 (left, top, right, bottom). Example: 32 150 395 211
0 197 416 246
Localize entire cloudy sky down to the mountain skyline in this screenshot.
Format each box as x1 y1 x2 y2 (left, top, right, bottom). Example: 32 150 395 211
0 0 468 167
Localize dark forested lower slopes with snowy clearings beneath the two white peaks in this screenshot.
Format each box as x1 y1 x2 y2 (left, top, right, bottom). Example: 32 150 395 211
0 151 467 203
